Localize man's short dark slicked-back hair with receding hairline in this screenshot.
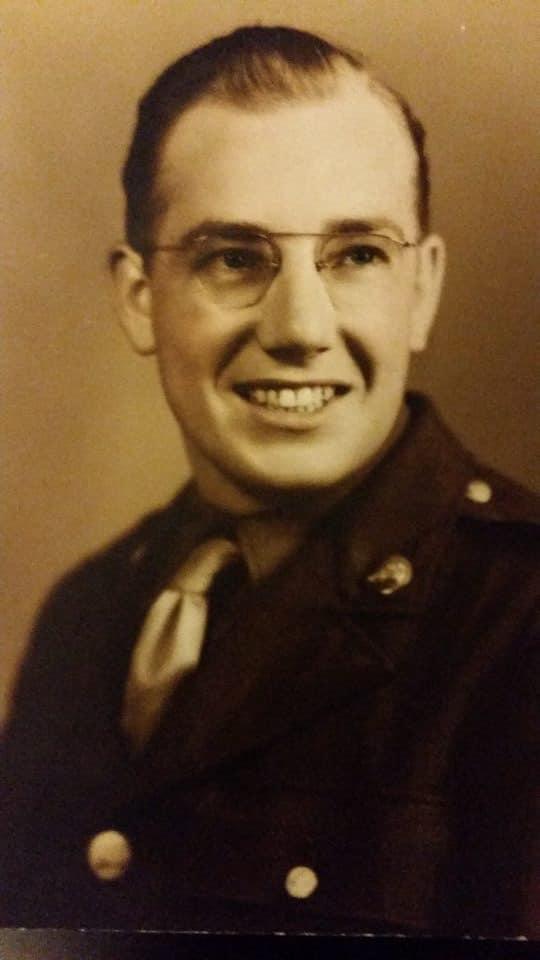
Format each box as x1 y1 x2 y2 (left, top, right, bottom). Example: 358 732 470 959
122 26 430 250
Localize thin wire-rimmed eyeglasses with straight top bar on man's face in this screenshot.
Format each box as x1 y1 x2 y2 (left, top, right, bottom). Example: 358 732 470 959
140 231 418 309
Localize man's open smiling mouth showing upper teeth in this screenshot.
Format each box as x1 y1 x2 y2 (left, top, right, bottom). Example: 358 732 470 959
234 380 350 413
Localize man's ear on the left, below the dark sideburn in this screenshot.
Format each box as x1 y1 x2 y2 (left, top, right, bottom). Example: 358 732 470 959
109 243 155 355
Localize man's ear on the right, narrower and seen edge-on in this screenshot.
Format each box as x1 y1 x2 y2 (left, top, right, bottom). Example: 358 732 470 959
409 233 446 353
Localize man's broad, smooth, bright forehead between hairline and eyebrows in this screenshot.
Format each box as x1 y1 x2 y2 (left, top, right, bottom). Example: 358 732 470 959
157 75 417 241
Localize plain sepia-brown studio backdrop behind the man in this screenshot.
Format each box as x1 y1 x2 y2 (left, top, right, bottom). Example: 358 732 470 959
0 0 540 709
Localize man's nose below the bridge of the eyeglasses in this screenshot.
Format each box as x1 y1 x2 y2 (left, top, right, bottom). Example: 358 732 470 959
252 251 336 363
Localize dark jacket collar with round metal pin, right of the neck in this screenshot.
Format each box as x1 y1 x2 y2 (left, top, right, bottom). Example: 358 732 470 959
338 393 471 612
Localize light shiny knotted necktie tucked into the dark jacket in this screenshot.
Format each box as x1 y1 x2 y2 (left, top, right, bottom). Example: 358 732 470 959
122 538 239 750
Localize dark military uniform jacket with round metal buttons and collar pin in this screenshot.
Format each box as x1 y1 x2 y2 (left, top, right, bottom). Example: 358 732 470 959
0 397 540 936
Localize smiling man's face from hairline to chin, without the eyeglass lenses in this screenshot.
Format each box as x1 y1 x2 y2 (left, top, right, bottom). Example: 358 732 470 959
117 76 437 509
